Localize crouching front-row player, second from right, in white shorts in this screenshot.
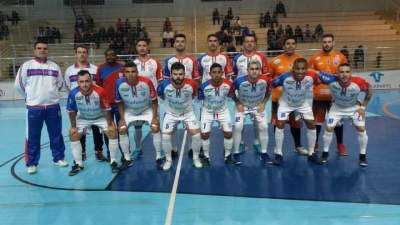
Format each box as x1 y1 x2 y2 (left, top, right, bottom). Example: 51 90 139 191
272 58 319 166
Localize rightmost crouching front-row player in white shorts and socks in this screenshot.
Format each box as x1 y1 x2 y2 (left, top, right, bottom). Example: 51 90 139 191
319 63 372 166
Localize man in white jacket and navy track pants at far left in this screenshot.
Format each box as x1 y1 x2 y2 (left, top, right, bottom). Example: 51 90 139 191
15 40 68 174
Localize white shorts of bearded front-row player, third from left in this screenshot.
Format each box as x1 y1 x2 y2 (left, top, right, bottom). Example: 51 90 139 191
162 111 200 133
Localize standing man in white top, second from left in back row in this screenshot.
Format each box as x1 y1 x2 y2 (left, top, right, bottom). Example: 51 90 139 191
64 45 101 161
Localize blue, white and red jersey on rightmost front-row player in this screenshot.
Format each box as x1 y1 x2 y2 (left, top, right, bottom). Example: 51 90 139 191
319 72 369 108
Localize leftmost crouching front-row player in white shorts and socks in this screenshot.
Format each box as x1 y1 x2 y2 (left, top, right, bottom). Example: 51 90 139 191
67 70 119 176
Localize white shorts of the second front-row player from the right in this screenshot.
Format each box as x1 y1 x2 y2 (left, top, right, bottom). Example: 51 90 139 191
277 101 314 120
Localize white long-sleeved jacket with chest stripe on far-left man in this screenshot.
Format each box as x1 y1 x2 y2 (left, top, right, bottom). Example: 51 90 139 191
14 57 64 106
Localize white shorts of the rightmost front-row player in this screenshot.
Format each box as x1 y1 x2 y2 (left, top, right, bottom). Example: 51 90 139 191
326 103 365 127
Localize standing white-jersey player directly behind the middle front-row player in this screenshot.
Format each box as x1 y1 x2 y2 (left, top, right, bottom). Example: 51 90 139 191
198 34 233 83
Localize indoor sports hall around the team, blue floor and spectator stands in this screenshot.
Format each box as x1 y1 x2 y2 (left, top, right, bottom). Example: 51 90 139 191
0 0 400 225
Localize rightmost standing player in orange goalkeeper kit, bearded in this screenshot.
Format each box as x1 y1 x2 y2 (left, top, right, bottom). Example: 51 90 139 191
309 34 347 156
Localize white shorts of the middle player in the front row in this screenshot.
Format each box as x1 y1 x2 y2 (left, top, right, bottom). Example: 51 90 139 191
201 108 232 133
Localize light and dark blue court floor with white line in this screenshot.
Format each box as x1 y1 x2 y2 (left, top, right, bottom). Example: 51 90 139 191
0 90 400 225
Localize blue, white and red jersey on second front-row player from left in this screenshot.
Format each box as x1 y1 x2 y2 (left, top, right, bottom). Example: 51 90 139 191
115 76 157 114
